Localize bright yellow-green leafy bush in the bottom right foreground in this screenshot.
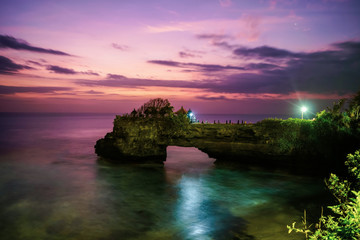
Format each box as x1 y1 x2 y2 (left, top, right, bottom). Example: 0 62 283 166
287 150 360 240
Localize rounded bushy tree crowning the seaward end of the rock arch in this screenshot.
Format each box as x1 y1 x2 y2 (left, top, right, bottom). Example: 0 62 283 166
136 98 174 117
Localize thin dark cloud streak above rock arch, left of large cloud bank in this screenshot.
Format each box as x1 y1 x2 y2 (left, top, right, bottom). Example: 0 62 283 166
148 60 245 72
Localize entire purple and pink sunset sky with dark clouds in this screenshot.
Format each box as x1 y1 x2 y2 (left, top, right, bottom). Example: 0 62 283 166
0 0 360 114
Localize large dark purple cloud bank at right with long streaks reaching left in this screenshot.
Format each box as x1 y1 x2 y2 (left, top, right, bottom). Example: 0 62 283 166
76 41 360 97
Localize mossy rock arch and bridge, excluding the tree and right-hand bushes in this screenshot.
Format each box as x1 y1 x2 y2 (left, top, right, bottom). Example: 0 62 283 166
95 116 302 168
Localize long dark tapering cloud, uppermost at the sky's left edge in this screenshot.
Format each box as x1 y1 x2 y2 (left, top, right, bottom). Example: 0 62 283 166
0 35 72 56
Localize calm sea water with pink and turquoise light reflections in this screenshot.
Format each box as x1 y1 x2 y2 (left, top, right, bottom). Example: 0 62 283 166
0 114 328 240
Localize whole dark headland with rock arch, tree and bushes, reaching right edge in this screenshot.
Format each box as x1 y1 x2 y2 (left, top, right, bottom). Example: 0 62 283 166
95 90 360 173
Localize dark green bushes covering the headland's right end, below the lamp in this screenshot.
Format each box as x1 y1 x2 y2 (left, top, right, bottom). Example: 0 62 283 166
256 92 360 170
